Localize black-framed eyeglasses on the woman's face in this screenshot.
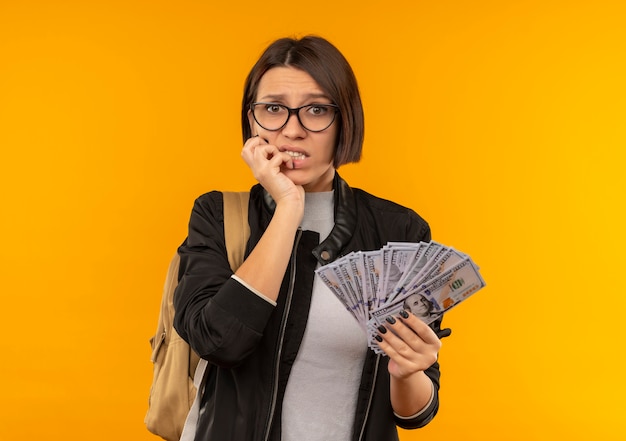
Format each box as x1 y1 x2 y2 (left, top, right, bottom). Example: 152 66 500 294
250 103 339 132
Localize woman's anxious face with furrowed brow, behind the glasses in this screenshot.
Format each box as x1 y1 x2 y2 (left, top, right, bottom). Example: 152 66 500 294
248 67 338 192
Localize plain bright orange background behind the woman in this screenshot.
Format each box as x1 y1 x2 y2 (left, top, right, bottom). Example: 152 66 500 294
0 0 626 441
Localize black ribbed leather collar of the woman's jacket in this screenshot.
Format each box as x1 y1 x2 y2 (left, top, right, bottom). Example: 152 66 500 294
263 172 356 265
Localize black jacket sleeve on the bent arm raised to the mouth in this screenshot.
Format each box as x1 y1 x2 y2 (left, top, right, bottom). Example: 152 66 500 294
174 192 274 367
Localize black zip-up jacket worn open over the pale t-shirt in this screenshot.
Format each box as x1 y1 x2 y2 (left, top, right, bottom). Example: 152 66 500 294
174 174 440 441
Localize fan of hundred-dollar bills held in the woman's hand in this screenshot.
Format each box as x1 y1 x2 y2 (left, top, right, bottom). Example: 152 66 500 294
316 242 485 353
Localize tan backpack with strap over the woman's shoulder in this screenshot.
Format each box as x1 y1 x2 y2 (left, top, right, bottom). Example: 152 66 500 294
144 192 250 441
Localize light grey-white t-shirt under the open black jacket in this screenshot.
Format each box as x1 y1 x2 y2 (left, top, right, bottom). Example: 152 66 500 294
282 191 367 441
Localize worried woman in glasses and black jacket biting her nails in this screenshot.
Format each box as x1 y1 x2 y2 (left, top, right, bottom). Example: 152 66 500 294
175 36 441 441
